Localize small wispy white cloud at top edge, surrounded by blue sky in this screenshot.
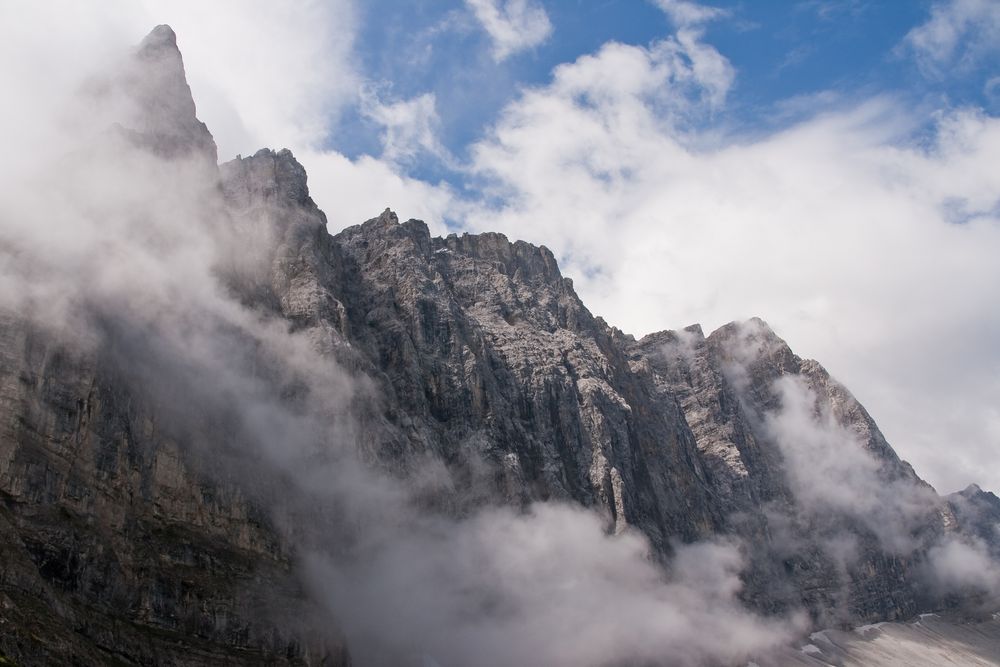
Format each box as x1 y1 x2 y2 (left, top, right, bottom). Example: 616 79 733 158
465 0 552 62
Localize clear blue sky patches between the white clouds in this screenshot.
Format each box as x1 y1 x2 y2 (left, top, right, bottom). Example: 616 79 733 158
325 0 1000 188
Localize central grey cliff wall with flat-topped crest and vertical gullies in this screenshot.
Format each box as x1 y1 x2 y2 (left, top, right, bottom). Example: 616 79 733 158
334 213 716 550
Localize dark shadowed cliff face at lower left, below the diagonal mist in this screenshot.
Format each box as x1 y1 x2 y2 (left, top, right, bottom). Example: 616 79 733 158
0 319 340 665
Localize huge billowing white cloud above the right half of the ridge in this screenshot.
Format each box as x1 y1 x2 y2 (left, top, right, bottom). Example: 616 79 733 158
467 38 1000 491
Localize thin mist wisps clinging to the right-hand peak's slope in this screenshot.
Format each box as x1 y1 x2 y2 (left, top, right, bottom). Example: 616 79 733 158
723 320 1000 608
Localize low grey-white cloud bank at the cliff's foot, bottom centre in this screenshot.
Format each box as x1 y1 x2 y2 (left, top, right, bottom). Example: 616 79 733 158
310 503 802 667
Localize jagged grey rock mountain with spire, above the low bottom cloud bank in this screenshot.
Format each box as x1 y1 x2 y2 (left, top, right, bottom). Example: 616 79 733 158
0 26 1000 665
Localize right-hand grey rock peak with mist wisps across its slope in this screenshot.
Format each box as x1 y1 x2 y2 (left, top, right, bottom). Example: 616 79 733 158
630 320 954 625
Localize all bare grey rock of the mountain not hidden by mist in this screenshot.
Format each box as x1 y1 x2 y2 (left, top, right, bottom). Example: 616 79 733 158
0 26 1000 665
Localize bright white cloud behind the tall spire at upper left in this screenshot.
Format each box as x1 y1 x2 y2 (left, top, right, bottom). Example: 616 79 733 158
0 0 462 247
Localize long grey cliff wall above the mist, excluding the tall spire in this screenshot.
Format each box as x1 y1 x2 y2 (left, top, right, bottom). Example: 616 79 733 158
223 146 976 623
